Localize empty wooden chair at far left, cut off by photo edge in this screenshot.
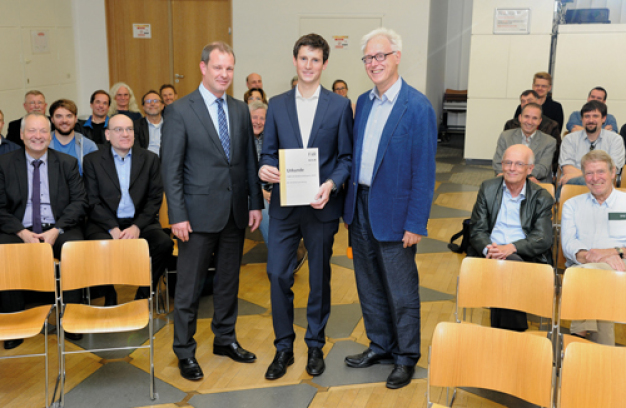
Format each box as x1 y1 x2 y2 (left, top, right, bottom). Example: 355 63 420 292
0 243 59 408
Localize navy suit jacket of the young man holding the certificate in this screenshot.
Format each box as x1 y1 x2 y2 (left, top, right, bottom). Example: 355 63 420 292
259 84 353 222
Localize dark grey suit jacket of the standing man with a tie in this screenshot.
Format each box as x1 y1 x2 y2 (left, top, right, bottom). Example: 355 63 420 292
161 89 263 233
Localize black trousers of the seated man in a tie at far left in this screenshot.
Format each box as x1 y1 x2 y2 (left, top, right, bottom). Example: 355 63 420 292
0 228 84 313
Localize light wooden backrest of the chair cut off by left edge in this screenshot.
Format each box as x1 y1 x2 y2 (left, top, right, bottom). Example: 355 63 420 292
0 243 56 292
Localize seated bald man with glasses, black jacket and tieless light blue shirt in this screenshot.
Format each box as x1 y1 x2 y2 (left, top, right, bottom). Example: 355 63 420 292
83 114 174 305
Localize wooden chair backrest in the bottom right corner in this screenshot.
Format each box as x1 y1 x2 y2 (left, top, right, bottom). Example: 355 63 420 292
560 343 626 408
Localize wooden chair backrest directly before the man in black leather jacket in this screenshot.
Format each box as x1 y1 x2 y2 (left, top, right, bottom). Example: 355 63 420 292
456 257 555 320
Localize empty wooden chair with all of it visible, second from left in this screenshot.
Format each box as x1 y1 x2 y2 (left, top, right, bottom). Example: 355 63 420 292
59 239 156 406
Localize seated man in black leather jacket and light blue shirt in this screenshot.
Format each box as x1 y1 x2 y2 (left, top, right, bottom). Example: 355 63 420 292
467 144 554 331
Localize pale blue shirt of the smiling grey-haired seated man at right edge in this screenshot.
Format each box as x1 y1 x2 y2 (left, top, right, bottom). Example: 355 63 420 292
561 189 626 266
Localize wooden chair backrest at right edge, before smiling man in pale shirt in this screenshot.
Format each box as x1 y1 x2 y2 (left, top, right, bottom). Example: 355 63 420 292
559 268 626 323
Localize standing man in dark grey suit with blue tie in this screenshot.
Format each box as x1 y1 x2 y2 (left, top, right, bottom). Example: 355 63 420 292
162 42 263 380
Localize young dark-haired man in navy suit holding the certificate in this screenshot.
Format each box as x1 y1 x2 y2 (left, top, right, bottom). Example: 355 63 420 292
259 34 352 380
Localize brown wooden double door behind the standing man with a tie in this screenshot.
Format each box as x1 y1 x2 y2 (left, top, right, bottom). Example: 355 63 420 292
105 0 232 101
